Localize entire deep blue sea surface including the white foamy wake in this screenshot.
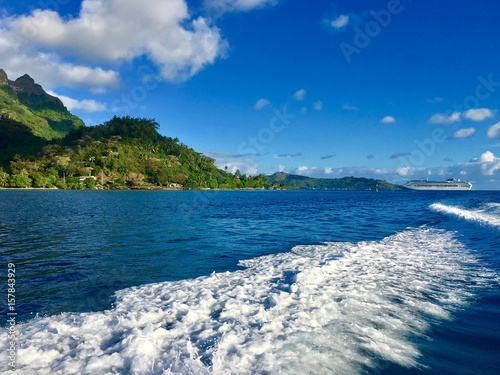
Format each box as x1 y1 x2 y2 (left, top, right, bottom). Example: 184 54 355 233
0 190 500 375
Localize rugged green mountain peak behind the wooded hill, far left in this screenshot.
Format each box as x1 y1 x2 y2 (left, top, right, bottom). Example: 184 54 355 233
0 69 84 140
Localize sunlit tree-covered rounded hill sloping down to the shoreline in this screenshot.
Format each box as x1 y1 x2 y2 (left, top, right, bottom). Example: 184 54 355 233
0 117 268 189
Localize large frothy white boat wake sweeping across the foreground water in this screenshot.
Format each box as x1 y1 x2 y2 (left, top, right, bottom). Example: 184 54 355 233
0 228 491 375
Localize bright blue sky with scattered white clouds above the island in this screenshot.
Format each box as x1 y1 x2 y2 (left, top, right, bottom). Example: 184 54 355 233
0 0 500 190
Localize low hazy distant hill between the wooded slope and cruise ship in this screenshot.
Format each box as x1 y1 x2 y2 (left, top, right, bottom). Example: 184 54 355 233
268 172 400 190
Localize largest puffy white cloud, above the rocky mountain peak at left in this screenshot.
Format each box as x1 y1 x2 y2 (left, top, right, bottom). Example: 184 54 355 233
0 0 227 85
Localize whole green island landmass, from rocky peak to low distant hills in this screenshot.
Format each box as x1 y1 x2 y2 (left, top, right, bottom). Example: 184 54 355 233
0 69 399 190
